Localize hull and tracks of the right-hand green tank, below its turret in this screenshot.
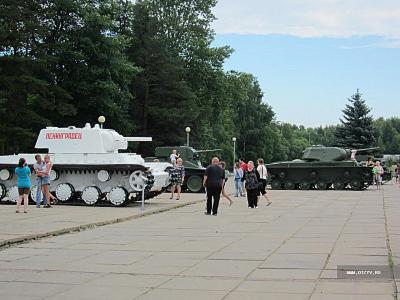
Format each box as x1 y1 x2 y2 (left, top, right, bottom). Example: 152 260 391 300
267 161 373 190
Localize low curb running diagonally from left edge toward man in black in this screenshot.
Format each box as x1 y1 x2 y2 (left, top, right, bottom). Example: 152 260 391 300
0 199 205 251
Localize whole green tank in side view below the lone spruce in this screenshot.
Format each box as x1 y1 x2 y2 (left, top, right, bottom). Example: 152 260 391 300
267 146 373 190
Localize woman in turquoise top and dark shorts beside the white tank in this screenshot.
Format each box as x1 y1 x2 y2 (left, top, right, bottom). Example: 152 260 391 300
15 158 31 213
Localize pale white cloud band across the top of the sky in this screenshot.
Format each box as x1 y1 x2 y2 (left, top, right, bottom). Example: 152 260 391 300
213 0 400 40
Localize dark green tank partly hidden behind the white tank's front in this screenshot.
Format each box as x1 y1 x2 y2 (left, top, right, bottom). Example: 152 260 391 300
145 146 221 193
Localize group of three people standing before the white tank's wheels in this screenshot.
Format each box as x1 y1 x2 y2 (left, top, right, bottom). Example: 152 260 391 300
15 154 55 213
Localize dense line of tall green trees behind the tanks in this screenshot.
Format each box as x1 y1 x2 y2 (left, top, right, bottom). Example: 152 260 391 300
0 0 400 161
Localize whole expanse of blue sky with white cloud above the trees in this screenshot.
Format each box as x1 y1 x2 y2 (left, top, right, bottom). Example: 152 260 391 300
213 0 400 126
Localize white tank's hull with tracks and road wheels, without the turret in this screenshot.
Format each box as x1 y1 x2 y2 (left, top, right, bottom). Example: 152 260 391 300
0 153 169 206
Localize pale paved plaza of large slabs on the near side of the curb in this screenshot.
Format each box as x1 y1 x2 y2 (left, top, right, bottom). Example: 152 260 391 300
0 185 400 300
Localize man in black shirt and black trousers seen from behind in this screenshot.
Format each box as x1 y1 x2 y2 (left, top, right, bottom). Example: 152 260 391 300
203 157 224 216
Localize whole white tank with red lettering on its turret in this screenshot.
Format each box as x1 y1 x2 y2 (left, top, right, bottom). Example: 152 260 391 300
0 124 172 206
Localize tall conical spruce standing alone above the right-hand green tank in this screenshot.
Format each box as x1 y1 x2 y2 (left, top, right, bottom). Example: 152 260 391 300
336 89 375 149
